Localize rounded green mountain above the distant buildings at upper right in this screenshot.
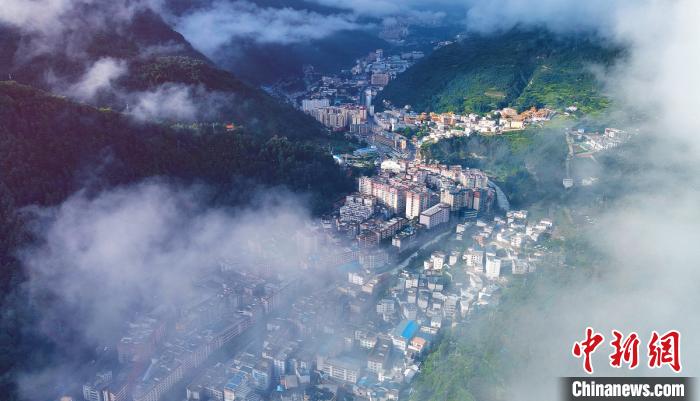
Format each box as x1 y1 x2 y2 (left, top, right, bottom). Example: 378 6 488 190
376 29 621 113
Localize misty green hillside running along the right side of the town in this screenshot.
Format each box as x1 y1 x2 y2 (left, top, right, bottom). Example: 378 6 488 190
411 136 656 401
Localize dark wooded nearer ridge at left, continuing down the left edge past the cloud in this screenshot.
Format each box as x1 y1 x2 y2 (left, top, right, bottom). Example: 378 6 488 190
0 82 353 400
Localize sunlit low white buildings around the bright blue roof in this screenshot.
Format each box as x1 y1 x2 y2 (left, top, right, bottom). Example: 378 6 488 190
286 206 553 400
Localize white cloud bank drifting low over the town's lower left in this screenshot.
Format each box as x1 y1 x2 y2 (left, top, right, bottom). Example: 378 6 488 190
23 181 326 344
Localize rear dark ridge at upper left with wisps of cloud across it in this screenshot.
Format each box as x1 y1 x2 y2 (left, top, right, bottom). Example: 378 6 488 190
0 10 325 140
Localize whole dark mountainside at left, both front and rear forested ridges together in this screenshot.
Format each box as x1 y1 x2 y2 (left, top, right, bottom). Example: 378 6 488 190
0 5 360 400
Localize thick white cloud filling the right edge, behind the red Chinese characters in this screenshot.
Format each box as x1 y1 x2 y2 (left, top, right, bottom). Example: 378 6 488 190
452 0 700 394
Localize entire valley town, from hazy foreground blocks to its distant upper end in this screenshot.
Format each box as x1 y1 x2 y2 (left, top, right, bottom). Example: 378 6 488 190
60 24 584 401
